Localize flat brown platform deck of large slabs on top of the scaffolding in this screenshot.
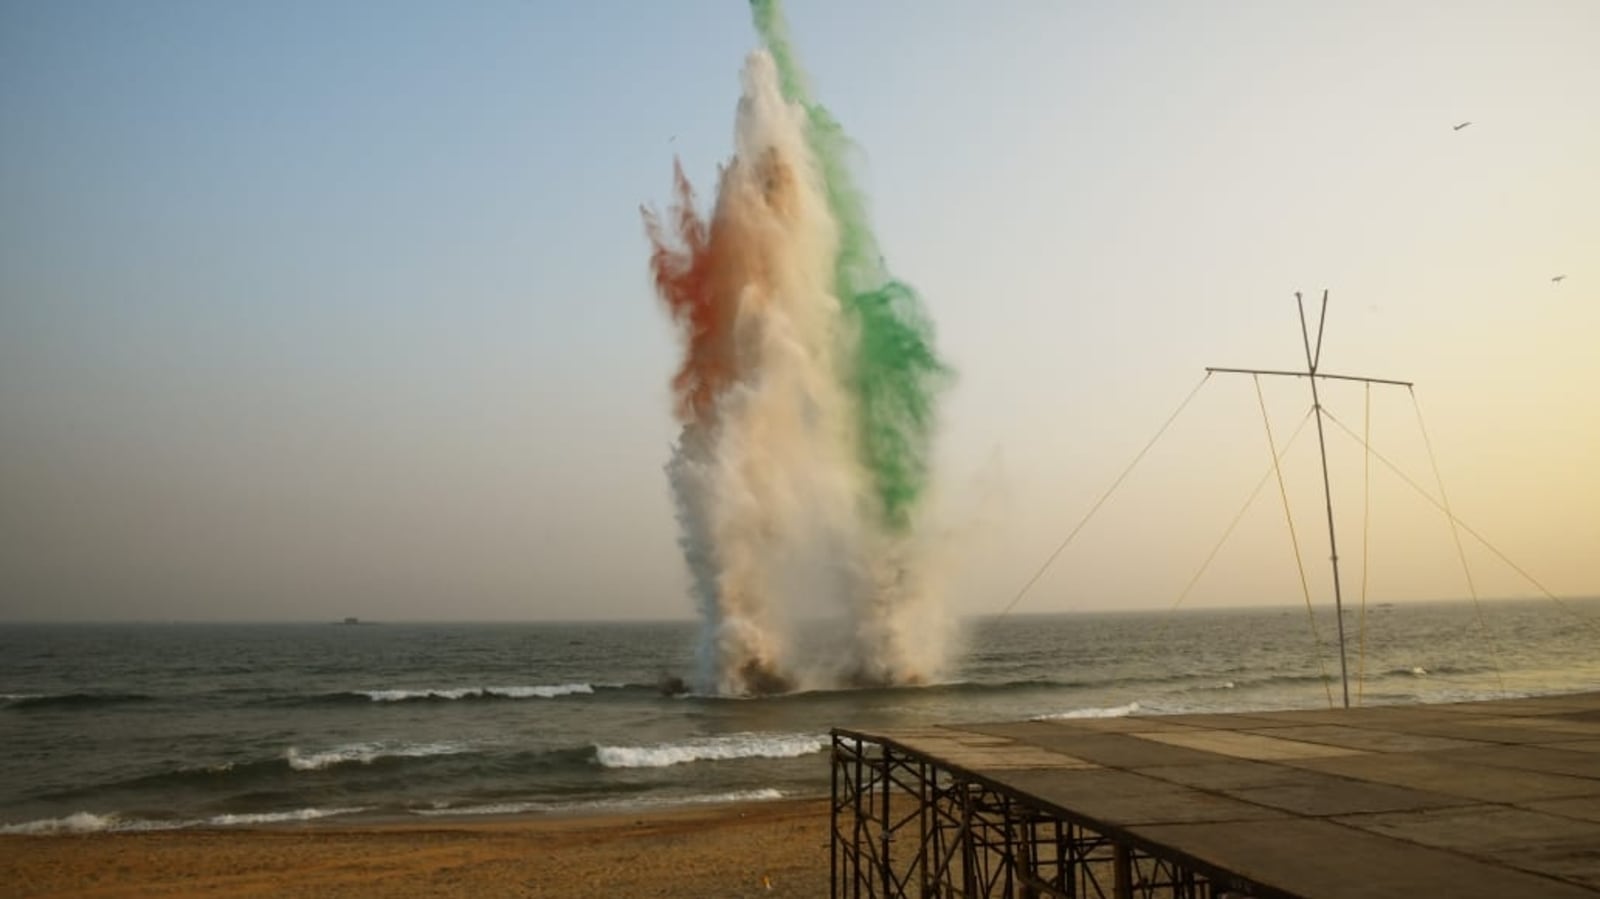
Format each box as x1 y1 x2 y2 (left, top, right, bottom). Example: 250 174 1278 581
853 693 1600 899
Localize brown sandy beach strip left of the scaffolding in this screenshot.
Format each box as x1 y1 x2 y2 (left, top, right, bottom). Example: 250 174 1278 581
9 800 829 899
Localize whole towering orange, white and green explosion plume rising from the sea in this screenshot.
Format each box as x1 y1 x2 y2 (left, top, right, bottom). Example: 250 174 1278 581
645 0 947 694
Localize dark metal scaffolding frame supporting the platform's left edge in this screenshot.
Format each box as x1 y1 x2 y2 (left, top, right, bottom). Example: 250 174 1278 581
830 729 1251 899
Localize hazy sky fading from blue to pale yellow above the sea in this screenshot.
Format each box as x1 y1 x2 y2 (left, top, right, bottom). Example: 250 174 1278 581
0 0 1600 621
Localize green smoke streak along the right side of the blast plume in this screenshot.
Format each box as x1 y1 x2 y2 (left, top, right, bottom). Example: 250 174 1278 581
750 0 950 531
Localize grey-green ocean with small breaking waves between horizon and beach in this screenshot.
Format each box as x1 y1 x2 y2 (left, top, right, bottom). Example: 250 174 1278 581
0 600 1600 833
